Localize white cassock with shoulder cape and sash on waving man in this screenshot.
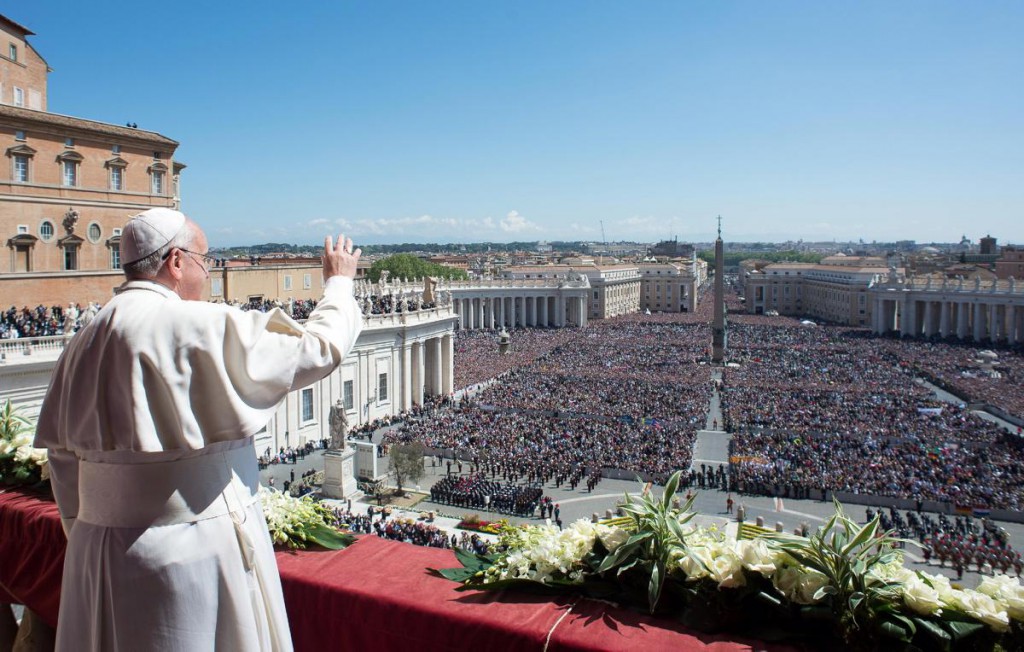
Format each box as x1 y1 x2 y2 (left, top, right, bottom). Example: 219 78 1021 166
36 276 362 652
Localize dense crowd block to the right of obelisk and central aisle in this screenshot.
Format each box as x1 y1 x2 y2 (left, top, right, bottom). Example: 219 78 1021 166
722 324 1024 510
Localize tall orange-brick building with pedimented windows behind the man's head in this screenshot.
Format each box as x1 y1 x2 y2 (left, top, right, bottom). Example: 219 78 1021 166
0 12 184 286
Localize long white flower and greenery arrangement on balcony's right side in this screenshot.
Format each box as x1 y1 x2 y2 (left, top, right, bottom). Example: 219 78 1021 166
434 473 1024 650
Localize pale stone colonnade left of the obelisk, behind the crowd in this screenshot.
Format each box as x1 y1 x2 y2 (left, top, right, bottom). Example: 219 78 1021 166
453 293 587 331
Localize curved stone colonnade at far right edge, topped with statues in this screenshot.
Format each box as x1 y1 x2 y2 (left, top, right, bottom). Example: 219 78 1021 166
871 292 1024 344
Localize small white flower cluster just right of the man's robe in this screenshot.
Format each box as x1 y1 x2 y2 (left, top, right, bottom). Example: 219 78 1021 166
259 486 355 550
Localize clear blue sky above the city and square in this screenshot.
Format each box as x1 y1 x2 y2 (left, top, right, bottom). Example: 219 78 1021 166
12 0 1024 245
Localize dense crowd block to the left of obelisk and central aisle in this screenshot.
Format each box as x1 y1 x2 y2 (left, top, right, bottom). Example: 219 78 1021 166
384 315 711 490
